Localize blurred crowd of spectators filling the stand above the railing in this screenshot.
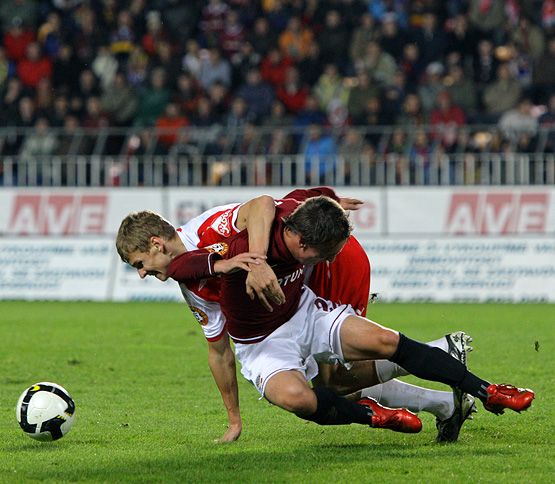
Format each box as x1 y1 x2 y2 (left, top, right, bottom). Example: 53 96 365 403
0 0 555 163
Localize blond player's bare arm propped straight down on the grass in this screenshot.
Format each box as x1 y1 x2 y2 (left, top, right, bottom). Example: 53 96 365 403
208 333 243 443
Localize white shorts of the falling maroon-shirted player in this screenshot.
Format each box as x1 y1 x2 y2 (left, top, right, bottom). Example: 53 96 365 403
235 286 356 396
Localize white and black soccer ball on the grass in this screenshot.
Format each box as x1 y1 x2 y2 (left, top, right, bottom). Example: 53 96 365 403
15 381 75 441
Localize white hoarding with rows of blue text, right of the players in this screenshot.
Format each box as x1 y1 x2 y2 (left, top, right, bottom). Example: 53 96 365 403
361 237 555 302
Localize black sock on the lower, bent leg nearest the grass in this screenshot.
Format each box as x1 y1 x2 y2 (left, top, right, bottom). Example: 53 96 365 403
299 387 372 425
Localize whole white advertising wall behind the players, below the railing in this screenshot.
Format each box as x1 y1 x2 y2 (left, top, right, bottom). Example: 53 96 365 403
0 187 555 302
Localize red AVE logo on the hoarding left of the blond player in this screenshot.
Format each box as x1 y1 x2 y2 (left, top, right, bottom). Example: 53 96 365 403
9 194 108 235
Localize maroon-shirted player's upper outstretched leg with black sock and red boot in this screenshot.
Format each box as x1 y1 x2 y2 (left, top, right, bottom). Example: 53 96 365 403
340 315 534 413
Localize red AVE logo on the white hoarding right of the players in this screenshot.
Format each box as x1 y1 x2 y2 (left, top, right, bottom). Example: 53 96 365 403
446 192 549 235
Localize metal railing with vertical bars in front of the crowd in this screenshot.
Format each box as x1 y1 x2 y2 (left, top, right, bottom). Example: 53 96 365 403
0 126 555 187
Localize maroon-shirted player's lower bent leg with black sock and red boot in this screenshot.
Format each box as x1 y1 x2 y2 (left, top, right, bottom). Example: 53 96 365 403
264 370 422 433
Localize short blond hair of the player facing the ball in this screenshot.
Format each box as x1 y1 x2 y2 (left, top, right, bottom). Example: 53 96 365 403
116 210 177 262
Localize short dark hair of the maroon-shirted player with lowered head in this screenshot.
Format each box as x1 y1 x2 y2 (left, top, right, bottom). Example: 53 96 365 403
283 196 352 253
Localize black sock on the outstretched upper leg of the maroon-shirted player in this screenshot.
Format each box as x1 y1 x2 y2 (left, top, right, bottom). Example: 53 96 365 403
390 333 489 399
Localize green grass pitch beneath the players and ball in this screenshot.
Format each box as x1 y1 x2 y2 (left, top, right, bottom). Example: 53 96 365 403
0 302 555 483
